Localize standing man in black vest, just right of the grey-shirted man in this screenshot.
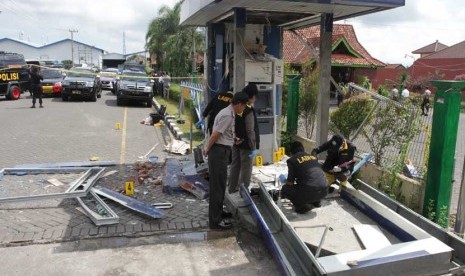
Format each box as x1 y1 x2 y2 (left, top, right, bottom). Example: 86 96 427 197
228 83 260 194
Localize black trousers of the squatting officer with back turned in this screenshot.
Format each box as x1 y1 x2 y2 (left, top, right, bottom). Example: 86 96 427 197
281 187 328 210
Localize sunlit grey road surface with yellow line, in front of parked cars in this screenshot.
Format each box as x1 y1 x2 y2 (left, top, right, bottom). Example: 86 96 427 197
0 90 166 168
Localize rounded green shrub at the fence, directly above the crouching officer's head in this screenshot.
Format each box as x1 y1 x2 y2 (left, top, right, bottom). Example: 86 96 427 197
329 94 374 138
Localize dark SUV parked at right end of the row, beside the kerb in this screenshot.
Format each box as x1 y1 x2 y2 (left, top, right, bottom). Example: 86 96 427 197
116 70 153 107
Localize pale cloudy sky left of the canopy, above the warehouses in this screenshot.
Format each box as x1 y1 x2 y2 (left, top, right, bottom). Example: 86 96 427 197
0 0 176 53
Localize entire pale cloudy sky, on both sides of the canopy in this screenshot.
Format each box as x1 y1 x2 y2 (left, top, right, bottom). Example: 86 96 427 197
0 0 465 66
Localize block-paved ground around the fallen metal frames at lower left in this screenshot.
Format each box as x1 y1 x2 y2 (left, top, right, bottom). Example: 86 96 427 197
0 164 208 247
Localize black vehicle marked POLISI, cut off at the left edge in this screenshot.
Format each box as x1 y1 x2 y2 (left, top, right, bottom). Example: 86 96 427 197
0 51 30 100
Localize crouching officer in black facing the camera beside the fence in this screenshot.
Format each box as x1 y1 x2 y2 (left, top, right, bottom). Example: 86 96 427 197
312 134 357 186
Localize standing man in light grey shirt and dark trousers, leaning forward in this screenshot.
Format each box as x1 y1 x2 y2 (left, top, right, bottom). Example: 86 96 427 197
204 92 249 229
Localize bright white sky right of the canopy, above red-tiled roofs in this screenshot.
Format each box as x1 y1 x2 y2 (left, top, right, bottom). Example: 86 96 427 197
346 0 465 65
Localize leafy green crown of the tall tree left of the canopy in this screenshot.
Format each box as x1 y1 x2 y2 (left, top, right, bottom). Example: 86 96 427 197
146 1 205 75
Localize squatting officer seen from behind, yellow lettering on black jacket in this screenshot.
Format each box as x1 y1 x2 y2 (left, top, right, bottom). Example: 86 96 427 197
280 142 328 214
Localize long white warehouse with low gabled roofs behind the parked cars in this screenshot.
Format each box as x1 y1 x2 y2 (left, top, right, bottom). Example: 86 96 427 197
0 38 104 67
